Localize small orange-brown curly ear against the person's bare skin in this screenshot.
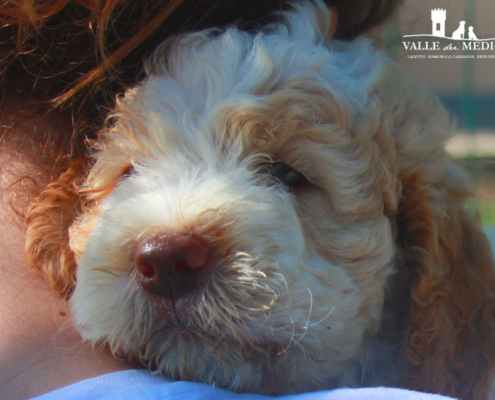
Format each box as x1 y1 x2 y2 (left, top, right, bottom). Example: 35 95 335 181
26 159 87 297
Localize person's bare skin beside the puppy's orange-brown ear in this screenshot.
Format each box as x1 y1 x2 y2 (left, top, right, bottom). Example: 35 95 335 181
0 107 130 400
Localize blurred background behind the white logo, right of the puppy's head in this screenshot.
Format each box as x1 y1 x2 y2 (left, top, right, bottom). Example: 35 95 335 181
383 0 495 249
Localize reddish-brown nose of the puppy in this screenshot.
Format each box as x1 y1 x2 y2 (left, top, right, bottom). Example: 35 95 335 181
134 234 210 298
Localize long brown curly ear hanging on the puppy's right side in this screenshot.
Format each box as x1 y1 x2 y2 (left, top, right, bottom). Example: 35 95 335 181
397 165 495 400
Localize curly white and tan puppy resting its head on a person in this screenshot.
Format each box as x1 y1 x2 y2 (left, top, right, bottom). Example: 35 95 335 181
27 1 495 400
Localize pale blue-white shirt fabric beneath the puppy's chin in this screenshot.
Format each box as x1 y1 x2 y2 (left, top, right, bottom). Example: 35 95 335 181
32 370 458 400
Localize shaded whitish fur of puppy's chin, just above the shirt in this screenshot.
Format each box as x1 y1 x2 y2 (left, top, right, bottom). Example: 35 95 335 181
126 326 340 395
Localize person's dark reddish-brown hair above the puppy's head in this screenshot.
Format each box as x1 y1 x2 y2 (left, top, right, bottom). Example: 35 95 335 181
0 0 401 168
